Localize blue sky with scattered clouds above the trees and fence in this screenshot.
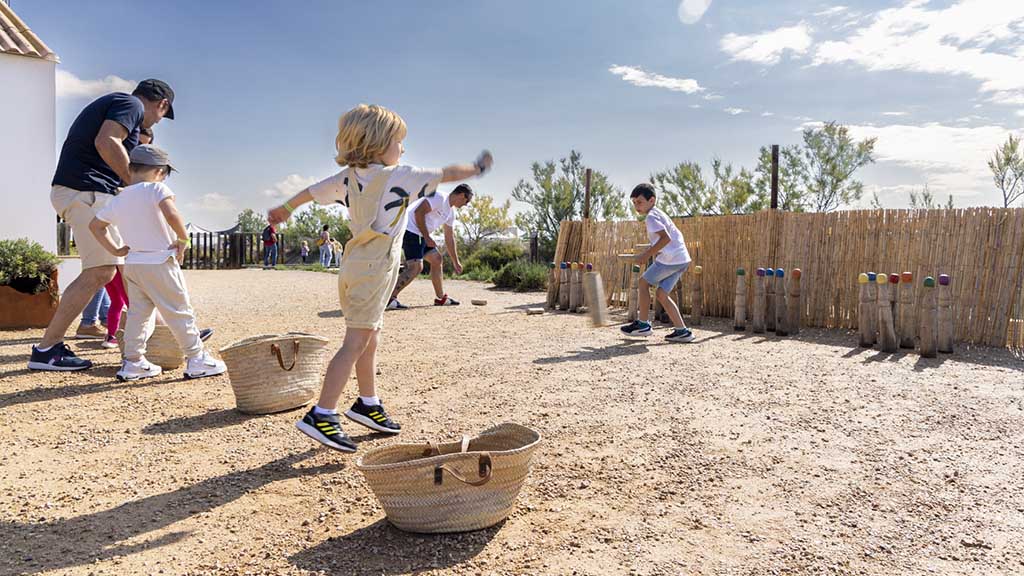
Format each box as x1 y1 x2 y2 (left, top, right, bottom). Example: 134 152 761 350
12 0 1024 228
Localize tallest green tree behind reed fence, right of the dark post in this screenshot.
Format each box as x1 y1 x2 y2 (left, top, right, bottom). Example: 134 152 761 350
800 122 878 212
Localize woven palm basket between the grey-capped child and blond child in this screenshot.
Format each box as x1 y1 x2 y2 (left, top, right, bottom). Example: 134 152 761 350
220 332 328 414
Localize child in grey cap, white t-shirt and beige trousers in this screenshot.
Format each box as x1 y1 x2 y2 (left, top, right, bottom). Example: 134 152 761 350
89 145 227 380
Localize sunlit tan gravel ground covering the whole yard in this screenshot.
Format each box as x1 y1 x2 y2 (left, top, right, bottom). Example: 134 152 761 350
0 270 1024 575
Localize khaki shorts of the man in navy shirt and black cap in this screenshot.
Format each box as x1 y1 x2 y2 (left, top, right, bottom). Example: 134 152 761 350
50 186 125 270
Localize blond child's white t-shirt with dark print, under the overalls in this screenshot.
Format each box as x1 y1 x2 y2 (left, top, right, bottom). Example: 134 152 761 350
309 164 442 238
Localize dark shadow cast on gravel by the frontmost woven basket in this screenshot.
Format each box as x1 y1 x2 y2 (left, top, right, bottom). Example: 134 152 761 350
288 512 505 574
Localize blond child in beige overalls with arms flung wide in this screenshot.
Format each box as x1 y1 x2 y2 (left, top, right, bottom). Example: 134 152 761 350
268 105 493 452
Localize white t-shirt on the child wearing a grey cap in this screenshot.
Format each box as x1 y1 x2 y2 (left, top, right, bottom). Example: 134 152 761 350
96 182 177 264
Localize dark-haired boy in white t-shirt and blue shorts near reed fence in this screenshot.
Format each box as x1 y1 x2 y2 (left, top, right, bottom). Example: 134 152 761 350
622 183 693 342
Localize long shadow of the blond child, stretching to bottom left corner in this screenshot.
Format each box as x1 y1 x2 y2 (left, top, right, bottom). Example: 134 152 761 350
0 450 344 576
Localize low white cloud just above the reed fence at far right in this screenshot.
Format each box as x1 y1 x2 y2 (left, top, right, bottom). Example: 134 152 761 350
801 122 1011 203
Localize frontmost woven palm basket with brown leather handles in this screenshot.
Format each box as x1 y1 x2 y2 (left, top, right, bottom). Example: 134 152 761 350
355 423 541 533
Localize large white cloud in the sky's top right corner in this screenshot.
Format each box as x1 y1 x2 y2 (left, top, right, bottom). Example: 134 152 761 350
812 0 1024 104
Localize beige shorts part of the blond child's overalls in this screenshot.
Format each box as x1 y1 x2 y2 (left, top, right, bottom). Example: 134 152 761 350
338 237 401 330
